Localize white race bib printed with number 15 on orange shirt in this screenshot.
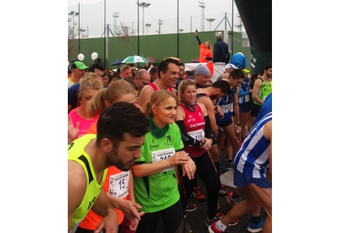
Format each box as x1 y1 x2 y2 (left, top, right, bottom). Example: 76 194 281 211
109 172 129 198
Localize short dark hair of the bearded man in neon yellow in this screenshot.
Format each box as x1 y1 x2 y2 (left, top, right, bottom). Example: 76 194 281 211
96 102 149 145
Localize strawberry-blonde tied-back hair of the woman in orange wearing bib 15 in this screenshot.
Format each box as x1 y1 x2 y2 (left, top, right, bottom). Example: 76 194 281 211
88 79 135 116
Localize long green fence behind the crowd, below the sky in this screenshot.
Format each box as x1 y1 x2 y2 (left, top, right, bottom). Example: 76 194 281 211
68 31 250 69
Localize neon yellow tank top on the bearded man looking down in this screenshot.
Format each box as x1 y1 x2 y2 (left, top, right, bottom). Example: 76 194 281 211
68 134 107 232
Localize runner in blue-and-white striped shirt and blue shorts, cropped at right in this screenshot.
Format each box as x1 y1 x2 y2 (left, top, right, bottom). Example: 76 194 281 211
208 112 272 233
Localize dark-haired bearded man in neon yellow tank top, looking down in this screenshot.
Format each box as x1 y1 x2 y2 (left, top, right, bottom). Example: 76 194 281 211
68 102 149 233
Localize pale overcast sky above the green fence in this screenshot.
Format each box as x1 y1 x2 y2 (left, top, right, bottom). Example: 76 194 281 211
67 0 240 38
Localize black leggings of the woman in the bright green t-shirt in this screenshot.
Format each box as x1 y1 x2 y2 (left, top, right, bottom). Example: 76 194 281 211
136 200 185 233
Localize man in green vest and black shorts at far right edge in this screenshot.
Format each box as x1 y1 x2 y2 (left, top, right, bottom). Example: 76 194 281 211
250 64 272 121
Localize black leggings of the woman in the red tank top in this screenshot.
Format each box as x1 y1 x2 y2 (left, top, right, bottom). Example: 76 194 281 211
179 152 220 219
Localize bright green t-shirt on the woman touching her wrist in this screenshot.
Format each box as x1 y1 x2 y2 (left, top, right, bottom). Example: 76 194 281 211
134 123 184 213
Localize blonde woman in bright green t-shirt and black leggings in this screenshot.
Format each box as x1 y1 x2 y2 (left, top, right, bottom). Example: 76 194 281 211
132 90 196 233
